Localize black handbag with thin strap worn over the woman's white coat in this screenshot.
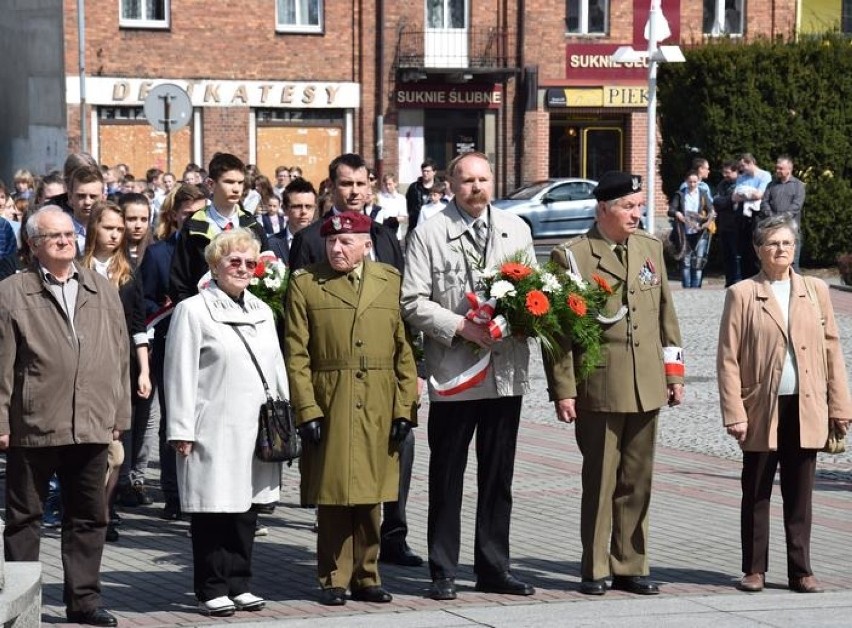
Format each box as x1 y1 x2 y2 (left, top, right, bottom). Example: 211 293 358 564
234 326 302 464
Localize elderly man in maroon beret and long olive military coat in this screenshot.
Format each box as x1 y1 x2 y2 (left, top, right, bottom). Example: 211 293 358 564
285 211 417 606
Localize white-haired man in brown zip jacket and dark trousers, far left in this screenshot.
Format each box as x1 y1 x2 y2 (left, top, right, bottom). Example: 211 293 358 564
0 206 130 626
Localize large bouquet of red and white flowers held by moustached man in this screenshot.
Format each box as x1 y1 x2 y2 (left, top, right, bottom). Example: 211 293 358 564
468 253 623 379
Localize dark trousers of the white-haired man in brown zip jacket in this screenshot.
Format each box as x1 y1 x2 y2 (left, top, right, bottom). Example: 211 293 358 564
3 445 107 611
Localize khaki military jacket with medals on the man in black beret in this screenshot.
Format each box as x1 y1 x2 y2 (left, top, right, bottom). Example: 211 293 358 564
545 226 683 412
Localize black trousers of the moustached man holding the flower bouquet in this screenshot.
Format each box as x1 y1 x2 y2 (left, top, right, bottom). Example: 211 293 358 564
427 397 522 580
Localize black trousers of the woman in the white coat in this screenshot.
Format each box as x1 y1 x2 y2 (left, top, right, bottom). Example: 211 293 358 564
190 510 257 602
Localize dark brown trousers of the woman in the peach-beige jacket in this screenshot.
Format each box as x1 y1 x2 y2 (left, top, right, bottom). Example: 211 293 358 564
741 395 817 578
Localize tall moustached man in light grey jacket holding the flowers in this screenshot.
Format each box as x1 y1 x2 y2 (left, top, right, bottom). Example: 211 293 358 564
402 153 535 600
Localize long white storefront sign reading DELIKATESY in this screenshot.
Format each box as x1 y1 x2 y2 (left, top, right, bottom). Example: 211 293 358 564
65 76 360 109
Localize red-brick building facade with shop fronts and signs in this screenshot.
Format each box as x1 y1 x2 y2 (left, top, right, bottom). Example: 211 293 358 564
36 0 812 206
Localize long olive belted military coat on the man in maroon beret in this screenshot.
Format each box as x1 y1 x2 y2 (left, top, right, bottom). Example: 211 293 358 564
285 261 417 506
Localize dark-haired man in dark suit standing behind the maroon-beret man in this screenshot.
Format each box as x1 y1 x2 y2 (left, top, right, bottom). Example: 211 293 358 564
289 153 423 567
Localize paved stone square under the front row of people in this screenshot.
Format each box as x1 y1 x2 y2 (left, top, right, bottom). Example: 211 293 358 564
1 281 852 628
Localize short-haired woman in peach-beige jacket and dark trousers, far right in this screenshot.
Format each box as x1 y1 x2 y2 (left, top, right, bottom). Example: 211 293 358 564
716 215 852 593
